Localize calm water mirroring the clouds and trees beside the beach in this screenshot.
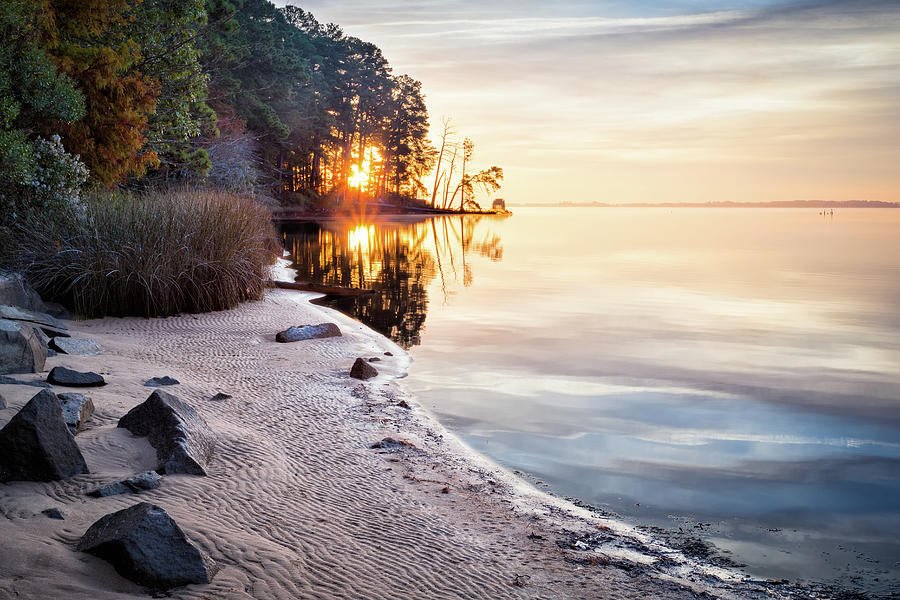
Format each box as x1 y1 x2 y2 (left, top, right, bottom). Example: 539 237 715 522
285 208 900 593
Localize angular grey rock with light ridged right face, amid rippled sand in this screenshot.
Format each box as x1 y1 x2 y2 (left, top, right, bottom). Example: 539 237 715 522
119 390 216 475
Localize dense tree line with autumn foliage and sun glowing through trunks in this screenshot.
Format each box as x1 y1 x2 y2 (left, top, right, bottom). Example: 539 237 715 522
0 0 436 219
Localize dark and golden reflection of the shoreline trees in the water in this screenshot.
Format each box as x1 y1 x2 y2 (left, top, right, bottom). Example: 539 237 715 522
281 215 503 348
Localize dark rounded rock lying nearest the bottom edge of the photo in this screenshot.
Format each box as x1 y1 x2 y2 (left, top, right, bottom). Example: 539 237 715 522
77 502 219 589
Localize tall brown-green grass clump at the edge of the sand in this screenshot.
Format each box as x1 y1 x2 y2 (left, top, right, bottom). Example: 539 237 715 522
14 191 277 318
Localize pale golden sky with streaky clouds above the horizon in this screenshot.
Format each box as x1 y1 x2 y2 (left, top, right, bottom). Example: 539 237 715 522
276 0 900 206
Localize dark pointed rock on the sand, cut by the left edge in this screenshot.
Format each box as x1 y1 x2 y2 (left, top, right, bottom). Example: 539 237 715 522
0 390 88 481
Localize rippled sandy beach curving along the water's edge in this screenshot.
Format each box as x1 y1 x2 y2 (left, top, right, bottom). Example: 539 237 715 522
0 290 822 599
